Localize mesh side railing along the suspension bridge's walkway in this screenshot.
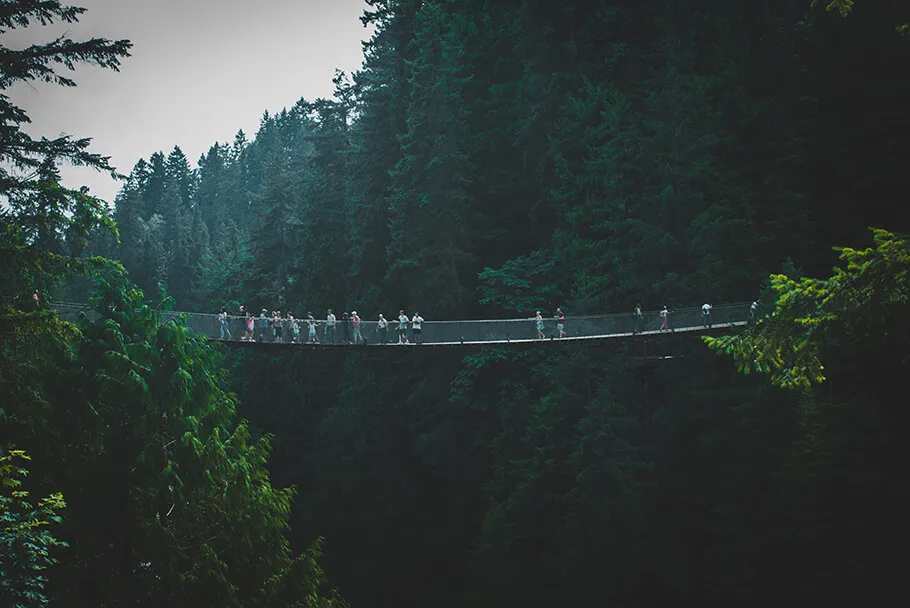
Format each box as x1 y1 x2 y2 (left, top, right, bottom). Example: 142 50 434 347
53 303 749 345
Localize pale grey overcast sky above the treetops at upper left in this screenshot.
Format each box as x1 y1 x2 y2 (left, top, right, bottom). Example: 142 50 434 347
3 0 370 201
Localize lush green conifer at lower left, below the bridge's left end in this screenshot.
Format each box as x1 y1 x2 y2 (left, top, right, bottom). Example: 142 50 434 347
0 283 346 606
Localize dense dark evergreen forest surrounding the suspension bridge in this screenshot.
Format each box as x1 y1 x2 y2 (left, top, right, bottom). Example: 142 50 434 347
0 0 910 608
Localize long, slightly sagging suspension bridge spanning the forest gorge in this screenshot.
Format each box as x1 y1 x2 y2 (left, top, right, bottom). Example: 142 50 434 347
51 302 750 348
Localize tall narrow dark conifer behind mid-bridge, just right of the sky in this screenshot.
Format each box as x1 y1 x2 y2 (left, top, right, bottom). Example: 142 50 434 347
387 4 476 317
